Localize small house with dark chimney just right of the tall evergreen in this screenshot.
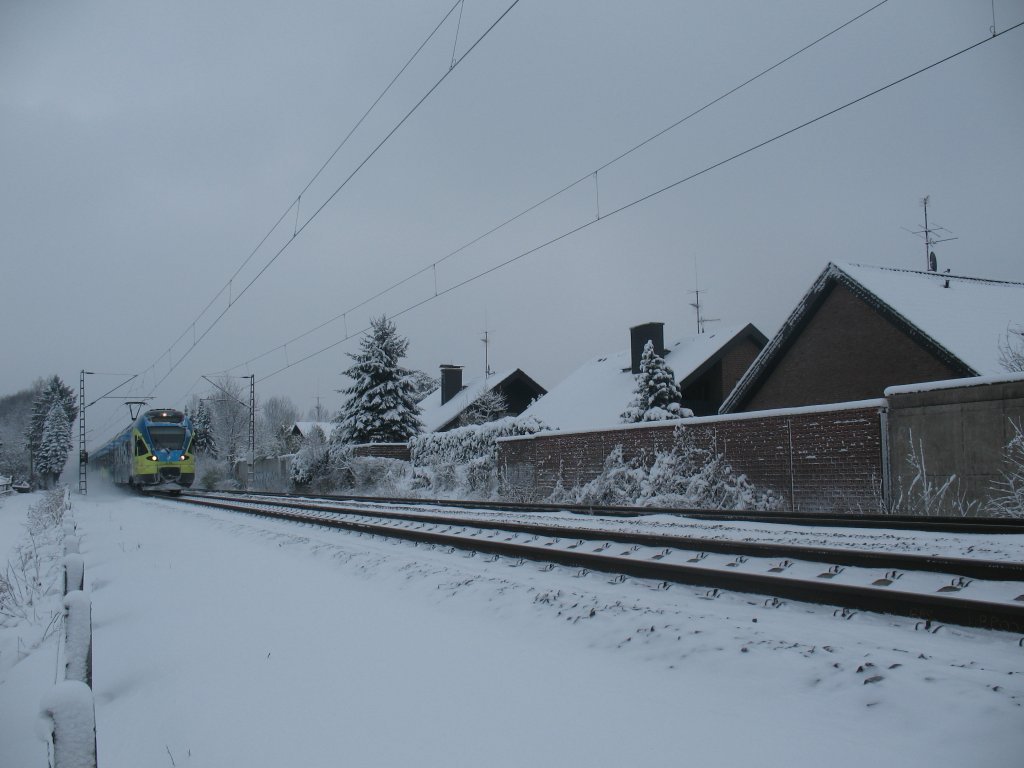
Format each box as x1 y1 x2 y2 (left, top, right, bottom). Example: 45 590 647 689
420 365 547 432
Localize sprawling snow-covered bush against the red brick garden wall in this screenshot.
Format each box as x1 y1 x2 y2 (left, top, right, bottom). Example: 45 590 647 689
551 425 782 510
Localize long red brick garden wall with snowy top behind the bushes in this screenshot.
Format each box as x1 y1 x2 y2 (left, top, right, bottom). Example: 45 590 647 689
498 403 882 512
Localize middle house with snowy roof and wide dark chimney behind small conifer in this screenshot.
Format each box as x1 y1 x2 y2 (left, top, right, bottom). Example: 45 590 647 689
526 323 768 430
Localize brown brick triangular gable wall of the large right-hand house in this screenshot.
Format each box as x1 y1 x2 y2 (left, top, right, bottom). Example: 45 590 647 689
742 285 959 411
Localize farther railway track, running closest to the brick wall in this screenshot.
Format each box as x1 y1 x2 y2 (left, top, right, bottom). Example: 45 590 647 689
191 490 1024 534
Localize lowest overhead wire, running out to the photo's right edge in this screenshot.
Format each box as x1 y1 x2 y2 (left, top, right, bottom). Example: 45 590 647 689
247 22 1024 383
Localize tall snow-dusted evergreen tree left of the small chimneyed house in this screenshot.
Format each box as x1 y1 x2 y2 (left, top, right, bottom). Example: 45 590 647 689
332 316 423 442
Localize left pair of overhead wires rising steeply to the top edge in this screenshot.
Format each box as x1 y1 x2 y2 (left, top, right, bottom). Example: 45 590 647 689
140 0 519 397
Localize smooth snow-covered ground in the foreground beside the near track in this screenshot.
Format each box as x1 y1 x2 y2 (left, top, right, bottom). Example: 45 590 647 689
0 488 1024 768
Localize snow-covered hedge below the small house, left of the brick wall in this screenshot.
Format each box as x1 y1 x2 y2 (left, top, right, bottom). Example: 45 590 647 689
409 416 547 498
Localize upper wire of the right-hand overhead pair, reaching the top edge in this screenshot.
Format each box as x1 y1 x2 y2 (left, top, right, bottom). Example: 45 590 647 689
211 0 889 371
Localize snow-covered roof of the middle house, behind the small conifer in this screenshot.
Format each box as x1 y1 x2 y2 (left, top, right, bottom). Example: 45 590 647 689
524 325 764 430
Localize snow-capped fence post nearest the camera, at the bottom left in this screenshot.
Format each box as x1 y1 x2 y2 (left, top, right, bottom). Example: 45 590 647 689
40 680 96 768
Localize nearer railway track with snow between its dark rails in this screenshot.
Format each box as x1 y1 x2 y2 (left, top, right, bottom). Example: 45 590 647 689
169 494 1024 633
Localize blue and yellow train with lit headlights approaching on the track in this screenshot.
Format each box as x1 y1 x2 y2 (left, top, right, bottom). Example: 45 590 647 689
92 409 196 494
